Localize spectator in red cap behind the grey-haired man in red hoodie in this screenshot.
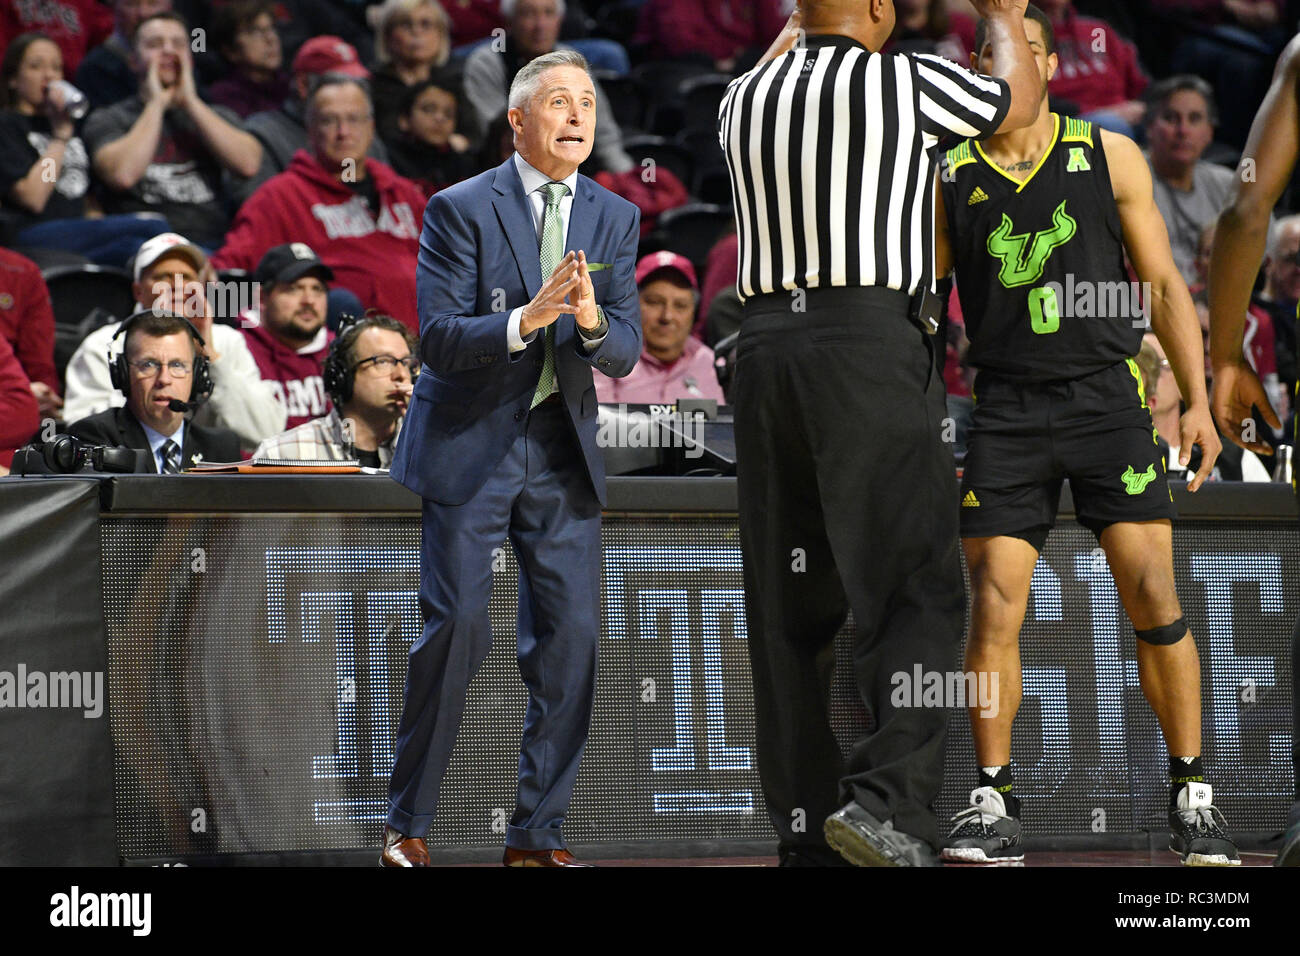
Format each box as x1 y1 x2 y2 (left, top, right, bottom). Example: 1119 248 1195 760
229 36 389 206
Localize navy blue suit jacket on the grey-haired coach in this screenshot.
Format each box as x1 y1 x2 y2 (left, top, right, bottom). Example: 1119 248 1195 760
390 157 641 505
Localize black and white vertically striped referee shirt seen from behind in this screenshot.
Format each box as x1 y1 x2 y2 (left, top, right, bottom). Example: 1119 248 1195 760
718 35 1011 299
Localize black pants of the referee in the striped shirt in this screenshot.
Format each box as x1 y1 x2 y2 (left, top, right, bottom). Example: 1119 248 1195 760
735 289 965 862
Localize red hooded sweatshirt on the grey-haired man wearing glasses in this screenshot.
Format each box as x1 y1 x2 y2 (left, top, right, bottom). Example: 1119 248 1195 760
212 150 425 334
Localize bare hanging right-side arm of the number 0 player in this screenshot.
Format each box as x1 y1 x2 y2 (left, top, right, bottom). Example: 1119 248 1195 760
1101 130 1223 492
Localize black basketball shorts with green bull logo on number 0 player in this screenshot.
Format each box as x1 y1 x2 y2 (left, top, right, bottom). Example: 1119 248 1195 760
961 359 1177 551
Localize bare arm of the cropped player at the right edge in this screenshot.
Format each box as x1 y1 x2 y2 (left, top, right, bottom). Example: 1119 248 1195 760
1209 30 1300 454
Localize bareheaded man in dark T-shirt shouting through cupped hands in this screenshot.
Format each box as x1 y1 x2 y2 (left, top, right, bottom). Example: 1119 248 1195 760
86 13 261 247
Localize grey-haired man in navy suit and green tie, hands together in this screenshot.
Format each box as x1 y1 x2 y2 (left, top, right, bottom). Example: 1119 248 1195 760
380 51 641 866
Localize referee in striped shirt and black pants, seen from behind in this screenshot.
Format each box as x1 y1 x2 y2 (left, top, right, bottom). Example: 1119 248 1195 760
719 0 1040 866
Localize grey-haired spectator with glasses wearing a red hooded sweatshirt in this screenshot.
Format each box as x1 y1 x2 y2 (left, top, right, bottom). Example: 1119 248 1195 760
213 74 425 330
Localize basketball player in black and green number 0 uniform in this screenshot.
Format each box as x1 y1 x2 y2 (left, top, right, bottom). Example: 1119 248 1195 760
936 5 1240 865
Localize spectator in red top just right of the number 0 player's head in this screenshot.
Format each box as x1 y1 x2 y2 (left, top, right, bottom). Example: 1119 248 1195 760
1037 0 1147 139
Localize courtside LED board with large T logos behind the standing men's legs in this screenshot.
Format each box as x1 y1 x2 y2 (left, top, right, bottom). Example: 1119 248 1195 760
94 479 1300 861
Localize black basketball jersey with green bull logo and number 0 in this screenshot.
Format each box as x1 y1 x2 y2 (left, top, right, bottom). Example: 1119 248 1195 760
941 113 1145 381
